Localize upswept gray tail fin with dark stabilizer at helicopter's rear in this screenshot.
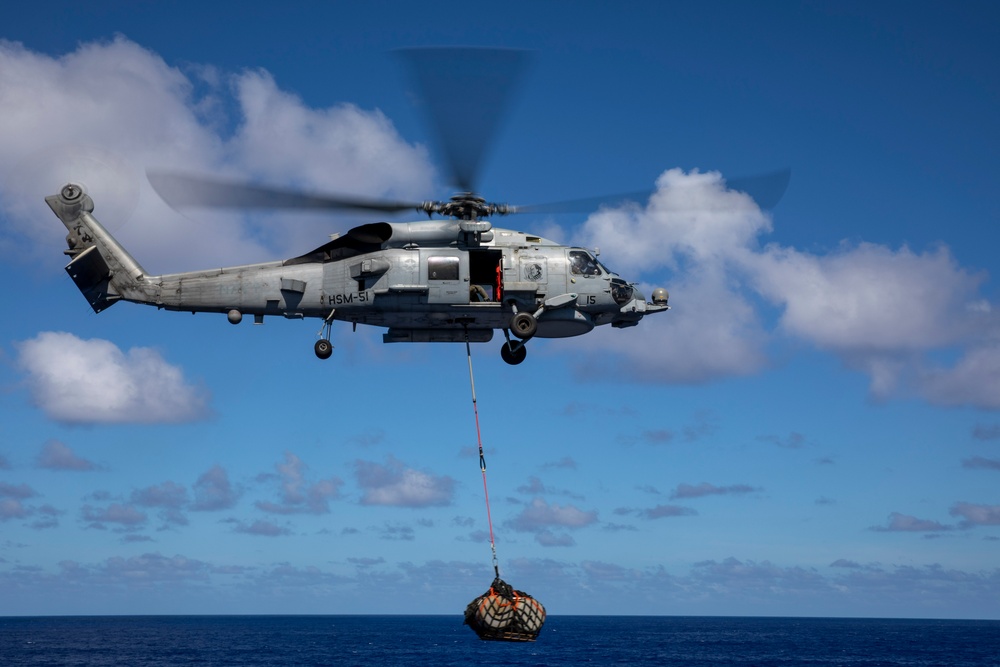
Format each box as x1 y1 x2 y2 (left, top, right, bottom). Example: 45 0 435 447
45 183 155 313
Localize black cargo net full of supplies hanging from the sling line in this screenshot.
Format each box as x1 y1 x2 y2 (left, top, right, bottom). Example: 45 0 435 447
465 577 545 642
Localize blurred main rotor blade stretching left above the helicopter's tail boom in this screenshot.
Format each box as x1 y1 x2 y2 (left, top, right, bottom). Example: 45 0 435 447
146 170 422 213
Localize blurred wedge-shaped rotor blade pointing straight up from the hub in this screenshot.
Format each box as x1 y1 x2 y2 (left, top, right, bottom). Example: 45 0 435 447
397 48 529 192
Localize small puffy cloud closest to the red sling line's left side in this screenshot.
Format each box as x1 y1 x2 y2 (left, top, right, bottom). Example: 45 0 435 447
354 456 455 507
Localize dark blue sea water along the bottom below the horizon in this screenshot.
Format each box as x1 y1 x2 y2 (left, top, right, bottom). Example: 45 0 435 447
0 616 1000 667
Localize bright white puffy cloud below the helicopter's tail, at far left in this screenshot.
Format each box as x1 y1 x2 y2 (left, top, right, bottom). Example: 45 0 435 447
17 331 208 424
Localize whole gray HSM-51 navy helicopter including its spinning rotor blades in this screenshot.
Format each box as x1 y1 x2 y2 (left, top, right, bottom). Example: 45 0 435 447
46 49 776 364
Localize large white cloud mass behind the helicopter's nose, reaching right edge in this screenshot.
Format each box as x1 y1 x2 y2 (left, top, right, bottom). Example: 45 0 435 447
574 169 1000 409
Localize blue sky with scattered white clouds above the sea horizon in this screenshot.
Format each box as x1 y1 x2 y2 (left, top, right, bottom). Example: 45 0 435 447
0 2 1000 618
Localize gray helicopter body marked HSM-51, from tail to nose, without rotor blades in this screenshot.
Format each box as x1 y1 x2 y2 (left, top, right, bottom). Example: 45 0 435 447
45 179 670 365
